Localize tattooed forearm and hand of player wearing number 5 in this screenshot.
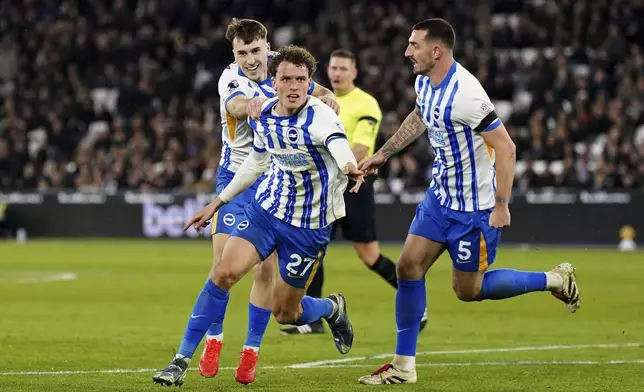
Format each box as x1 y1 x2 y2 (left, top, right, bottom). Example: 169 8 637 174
358 108 427 174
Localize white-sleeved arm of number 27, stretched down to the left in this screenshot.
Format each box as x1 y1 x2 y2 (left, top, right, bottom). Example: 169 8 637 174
183 149 270 231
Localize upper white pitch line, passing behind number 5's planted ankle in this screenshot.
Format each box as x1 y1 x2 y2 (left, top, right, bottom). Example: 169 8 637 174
291 343 642 368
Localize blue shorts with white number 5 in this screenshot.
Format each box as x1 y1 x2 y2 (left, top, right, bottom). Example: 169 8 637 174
409 189 501 272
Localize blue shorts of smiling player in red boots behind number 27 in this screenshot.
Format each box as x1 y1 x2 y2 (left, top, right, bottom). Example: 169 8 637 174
211 166 264 235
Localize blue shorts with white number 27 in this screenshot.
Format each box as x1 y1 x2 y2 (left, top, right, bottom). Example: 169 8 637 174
231 200 331 288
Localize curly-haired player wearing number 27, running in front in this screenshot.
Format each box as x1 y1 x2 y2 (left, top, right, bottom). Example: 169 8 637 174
156 46 364 384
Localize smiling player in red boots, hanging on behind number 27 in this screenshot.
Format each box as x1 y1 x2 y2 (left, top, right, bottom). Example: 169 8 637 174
153 19 338 384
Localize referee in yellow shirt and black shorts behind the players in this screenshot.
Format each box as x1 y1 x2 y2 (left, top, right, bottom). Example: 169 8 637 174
282 49 427 335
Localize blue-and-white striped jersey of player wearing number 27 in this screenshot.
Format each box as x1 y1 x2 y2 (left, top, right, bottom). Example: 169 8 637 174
248 97 348 229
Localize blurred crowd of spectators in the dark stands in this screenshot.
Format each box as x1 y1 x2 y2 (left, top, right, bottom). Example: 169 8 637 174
0 0 644 192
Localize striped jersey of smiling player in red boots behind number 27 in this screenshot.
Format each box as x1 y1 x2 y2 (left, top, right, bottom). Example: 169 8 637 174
218 63 315 173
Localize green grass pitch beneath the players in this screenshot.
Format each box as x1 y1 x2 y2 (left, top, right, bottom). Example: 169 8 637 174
0 239 644 392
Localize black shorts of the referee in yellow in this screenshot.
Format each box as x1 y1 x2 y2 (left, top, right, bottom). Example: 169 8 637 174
332 177 376 243
